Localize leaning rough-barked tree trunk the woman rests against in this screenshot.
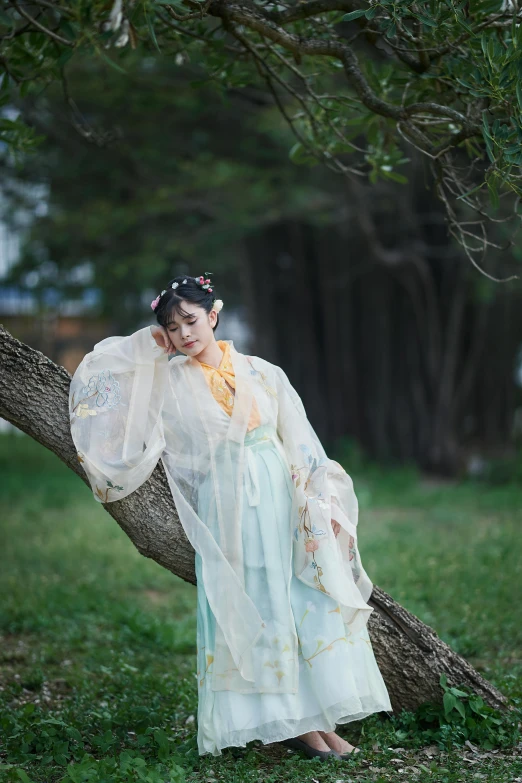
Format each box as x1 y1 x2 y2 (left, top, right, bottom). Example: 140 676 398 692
0 325 507 711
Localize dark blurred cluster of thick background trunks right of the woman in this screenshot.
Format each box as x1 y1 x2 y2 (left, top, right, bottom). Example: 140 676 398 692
243 186 522 477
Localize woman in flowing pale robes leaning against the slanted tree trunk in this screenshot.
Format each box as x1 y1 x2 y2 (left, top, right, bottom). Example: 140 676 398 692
70 276 391 760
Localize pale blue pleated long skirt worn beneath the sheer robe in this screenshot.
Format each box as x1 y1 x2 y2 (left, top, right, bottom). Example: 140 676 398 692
195 425 392 756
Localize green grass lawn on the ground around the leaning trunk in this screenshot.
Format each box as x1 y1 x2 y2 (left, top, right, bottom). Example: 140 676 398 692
0 435 522 783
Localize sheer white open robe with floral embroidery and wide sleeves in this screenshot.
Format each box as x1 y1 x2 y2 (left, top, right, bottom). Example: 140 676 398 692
70 327 373 693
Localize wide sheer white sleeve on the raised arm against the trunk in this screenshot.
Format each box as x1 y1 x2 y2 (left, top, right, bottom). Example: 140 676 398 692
69 326 168 503
